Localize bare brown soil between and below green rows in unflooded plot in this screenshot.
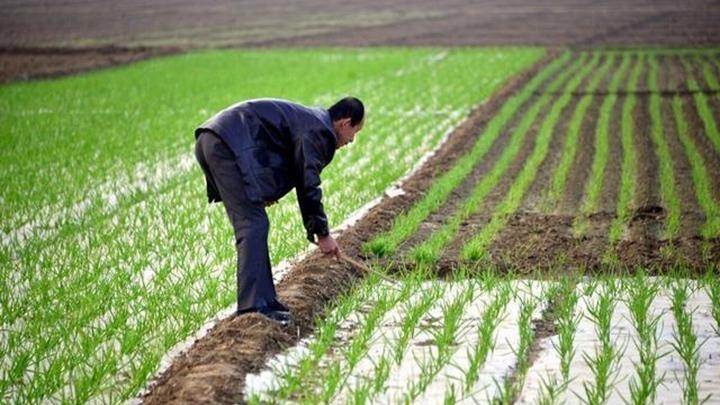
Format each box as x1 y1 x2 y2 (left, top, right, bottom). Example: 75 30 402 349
394 50 720 277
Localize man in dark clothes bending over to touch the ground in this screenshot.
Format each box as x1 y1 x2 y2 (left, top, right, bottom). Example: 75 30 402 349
195 97 365 325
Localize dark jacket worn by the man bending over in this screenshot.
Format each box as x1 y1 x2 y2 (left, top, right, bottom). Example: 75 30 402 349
195 99 337 241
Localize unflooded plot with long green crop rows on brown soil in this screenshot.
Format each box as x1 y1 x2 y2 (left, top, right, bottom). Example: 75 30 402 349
365 51 720 270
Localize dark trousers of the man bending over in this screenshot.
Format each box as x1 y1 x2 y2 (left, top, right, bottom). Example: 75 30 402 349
195 132 285 313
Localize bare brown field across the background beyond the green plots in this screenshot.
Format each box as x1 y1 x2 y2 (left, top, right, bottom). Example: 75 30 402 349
0 0 720 82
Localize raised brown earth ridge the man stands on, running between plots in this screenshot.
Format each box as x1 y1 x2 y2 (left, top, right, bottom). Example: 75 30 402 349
143 49 554 404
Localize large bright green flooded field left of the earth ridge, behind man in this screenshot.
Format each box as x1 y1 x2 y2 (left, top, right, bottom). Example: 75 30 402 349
0 48 545 403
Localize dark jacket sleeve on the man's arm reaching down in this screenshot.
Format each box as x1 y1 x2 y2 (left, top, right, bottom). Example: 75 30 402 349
294 132 330 242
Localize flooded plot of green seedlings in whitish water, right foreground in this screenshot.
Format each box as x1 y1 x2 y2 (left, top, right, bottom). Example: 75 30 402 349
246 268 720 404
